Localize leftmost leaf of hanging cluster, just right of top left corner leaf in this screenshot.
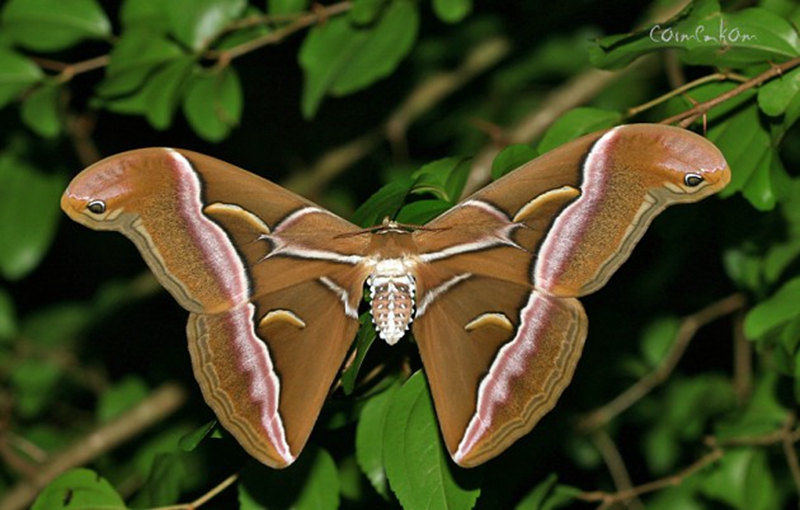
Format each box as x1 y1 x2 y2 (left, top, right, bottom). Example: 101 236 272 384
97 29 183 97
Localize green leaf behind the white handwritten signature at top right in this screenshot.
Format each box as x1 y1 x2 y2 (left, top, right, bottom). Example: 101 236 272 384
590 0 800 69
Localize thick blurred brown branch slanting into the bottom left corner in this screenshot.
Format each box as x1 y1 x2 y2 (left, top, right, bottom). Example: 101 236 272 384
0 383 186 510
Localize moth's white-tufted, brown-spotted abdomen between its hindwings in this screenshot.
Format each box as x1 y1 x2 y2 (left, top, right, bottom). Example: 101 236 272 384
367 273 416 345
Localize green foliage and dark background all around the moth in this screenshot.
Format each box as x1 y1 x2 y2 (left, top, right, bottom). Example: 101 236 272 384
0 0 800 510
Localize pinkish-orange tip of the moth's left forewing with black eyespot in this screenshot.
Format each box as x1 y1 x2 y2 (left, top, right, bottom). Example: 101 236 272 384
61 149 173 230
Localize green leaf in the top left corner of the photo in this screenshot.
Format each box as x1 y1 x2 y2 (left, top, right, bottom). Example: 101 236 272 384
3 0 111 51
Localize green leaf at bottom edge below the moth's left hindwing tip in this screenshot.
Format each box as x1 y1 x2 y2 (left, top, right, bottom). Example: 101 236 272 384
239 446 339 510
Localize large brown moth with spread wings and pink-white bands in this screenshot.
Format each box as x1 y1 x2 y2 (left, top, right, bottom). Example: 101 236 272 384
61 124 730 468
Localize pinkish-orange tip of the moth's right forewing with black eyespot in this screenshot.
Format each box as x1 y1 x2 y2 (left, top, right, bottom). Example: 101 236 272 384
620 124 731 202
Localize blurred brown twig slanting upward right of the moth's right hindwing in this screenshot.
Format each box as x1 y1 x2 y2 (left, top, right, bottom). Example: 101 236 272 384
578 294 745 431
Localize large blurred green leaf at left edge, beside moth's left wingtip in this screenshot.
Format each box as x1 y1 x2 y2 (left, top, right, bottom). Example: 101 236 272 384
0 153 66 280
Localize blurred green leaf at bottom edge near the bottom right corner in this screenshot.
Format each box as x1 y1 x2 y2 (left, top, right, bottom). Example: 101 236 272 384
703 448 781 510
